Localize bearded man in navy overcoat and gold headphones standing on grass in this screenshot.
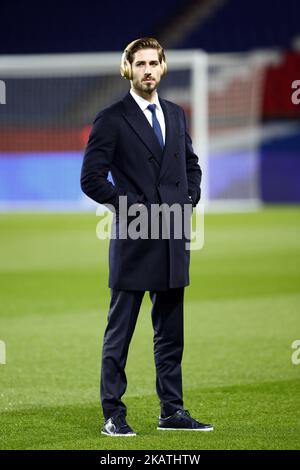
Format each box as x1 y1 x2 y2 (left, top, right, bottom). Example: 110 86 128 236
81 38 213 437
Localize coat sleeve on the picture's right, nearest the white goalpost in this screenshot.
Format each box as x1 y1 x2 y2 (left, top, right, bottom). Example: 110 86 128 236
182 110 202 207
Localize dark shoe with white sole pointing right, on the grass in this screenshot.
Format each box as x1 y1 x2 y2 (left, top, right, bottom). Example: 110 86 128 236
157 410 214 431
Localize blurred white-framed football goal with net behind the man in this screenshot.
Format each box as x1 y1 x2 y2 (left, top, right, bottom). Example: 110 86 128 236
0 50 276 210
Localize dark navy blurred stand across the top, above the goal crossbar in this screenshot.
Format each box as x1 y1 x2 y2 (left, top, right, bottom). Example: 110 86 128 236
0 0 300 54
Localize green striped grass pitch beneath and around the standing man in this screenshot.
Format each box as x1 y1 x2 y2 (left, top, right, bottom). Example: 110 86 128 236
0 207 300 450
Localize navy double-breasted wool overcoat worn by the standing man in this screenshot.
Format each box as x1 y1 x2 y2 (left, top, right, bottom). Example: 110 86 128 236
81 93 201 291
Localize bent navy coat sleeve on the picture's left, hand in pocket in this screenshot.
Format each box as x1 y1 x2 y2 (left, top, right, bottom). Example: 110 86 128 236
80 112 145 209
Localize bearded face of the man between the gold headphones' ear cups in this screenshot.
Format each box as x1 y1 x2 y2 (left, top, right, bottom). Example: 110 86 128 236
132 49 162 96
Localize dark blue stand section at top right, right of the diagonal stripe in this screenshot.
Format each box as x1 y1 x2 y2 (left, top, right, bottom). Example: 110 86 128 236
181 0 300 52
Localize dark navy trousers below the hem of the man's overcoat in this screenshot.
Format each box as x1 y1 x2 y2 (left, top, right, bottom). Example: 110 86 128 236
101 287 184 419
